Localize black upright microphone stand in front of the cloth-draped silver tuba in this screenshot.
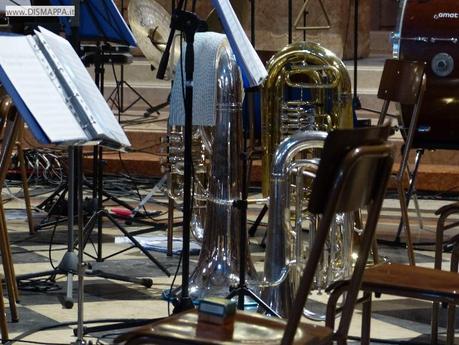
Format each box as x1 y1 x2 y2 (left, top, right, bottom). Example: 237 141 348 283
156 0 200 314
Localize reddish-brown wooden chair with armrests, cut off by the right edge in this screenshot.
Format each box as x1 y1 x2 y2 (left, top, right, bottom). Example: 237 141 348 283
326 194 459 345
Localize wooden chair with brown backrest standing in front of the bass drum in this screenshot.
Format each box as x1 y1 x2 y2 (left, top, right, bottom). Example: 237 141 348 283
378 59 426 265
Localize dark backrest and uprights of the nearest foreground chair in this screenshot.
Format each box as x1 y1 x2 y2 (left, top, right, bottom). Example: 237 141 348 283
282 127 393 345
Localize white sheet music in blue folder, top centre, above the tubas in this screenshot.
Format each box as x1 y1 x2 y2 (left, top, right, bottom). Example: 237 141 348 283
212 0 268 88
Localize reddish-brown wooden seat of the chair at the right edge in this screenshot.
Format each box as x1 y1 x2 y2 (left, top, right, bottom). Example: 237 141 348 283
362 264 459 303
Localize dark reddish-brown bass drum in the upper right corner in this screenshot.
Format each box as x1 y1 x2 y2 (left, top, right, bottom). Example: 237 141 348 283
394 0 459 149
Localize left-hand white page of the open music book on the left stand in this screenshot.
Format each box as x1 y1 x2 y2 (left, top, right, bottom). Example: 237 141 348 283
0 36 88 144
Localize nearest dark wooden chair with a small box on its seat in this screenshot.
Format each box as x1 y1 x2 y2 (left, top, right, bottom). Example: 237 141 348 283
115 127 393 345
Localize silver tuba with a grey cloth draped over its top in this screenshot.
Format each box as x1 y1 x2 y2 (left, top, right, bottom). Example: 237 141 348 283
165 33 257 300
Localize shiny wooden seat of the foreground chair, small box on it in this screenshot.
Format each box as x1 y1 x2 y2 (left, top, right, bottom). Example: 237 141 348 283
115 310 332 345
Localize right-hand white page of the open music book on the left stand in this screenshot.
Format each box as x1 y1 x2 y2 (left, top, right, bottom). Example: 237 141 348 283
37 27 131 147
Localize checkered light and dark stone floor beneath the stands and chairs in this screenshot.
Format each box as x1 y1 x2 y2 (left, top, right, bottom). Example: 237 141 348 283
0 179 455 344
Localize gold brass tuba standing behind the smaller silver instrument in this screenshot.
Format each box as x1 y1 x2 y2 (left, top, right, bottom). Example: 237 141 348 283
261 42 352 196
